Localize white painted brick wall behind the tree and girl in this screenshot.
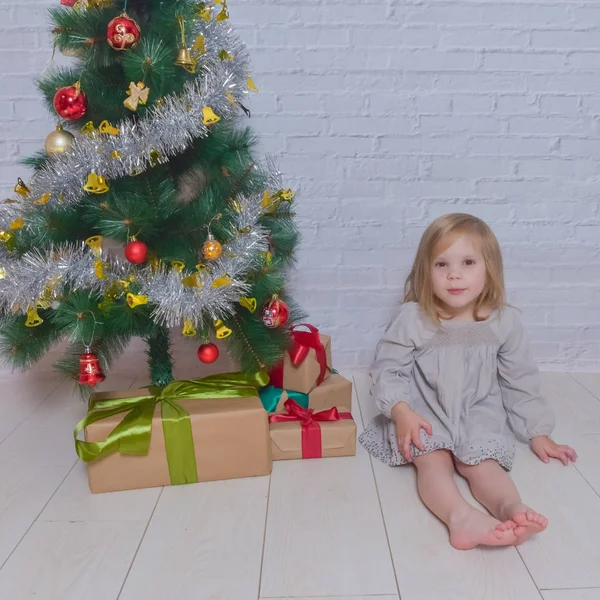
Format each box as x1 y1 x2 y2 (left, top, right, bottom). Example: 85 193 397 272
0 0 600 370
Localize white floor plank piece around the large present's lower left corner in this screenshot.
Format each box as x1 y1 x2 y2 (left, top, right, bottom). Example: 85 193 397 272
40 462 160 523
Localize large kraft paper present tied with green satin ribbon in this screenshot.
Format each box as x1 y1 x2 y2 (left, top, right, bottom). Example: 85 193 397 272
75 373 272 493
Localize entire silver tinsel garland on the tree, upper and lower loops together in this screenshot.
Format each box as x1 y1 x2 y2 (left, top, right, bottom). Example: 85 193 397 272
0 7 281 326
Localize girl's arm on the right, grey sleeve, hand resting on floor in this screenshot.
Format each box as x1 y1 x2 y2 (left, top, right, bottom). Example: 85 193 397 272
498 307 577 464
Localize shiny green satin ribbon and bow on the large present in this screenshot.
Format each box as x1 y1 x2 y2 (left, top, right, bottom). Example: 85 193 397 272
74 371 269 485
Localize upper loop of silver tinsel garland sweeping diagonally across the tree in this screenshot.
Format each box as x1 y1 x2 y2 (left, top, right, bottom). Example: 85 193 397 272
0 14 249 229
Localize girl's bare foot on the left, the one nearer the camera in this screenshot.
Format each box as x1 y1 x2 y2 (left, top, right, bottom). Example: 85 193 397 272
448 506 518 550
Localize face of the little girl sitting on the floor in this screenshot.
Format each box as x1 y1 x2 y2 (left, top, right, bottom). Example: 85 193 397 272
431 235 486 317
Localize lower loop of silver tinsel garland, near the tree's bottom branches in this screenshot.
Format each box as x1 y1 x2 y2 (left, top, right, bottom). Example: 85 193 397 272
0 179 269 327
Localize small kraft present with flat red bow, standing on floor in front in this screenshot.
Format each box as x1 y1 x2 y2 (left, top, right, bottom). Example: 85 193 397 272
269 399 356 460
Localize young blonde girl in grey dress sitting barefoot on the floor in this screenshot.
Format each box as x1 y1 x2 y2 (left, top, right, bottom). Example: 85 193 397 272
360 214 577 550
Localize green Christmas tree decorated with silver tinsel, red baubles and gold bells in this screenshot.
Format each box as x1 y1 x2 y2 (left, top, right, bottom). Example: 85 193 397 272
0 0 298 389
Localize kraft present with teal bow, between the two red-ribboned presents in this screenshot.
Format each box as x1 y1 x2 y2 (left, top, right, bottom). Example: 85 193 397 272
259 371 352 413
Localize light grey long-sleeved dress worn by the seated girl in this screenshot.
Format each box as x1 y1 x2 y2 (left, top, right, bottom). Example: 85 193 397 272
359 302 554 470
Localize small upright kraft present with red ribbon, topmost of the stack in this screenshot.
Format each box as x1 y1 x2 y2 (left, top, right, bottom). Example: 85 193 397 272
269 324 332 394
